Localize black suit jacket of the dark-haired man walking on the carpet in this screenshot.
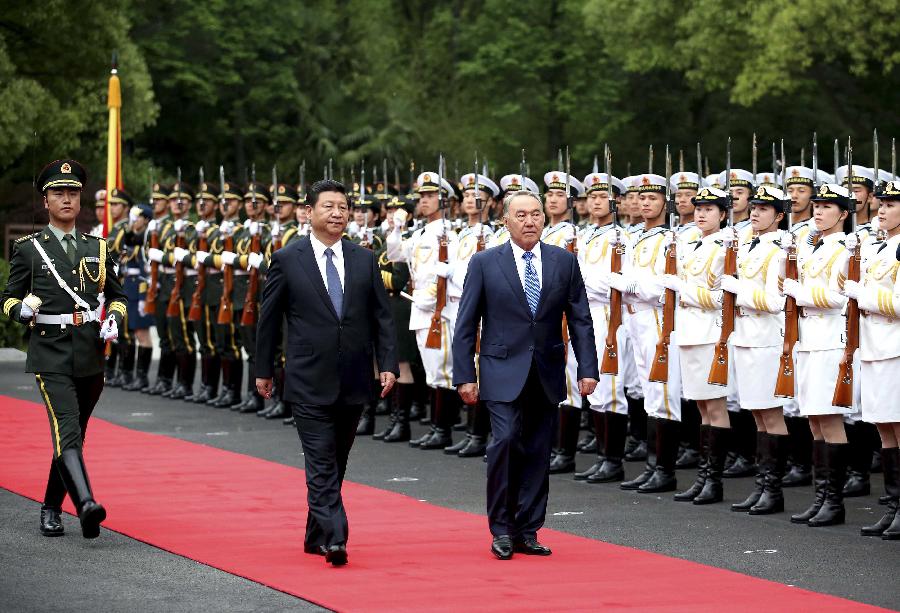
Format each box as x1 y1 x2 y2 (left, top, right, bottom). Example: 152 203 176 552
256 236 400 405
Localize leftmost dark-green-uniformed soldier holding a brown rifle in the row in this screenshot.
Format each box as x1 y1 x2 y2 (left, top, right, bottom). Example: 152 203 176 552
141 183 181 396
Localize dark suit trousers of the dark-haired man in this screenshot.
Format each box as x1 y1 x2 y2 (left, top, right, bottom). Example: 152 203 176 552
291 403 366 549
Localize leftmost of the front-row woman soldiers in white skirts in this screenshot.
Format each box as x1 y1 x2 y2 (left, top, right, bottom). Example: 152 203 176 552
662 187 731 504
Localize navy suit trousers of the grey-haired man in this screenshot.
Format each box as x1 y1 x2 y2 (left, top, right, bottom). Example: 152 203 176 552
485 362 557 538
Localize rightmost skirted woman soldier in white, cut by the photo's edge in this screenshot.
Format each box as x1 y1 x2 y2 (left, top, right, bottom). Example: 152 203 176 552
844 181 900 540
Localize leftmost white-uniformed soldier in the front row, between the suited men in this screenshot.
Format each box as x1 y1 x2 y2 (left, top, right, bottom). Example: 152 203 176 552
386 172 461 449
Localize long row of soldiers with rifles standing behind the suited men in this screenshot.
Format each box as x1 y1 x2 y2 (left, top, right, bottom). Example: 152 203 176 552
98 149 900 538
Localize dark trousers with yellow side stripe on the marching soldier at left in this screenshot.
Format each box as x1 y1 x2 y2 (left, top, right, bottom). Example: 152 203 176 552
35 373 103 509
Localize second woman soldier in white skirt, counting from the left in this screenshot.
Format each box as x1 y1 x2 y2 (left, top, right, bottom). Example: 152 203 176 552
721 186 788 515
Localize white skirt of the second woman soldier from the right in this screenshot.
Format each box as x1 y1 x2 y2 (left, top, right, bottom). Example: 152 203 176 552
794 349 856 417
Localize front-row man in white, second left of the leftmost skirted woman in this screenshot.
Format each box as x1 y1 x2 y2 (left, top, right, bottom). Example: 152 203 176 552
575 172 629 483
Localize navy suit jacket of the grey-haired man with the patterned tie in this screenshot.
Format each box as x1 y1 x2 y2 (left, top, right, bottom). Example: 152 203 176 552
453 243 599 402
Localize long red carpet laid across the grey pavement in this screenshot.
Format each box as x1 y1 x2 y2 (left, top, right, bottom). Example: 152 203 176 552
0 396 878 613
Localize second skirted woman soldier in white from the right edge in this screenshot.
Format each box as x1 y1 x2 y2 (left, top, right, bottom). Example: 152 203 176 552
784 183 858 527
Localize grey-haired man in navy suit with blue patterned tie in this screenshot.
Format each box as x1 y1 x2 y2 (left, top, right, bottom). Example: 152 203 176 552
453 191 599 560
